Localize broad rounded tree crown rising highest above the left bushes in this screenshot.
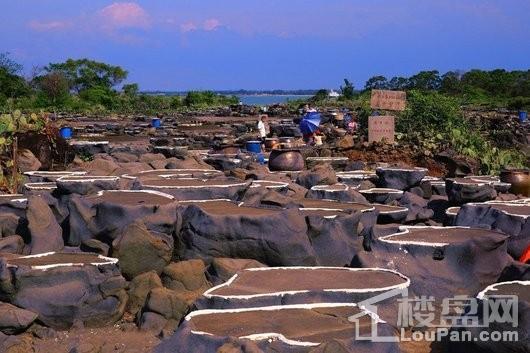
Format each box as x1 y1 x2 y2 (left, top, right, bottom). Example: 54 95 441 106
45 59 128 93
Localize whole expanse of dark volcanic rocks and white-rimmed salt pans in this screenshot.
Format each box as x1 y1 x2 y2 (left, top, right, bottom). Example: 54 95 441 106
0 113 530 353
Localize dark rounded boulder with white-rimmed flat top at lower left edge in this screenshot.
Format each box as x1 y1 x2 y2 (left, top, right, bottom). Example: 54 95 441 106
0 254 127 329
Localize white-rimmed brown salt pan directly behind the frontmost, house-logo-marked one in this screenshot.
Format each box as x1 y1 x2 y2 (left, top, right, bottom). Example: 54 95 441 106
197 267 410 309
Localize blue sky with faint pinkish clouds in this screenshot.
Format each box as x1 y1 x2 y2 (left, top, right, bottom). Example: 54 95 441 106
0 0 530 90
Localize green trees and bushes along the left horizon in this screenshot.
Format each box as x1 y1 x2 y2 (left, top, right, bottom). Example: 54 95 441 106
0 53 239 114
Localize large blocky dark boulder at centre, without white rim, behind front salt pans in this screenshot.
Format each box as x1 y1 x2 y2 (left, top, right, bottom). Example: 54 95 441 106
176 203 316 265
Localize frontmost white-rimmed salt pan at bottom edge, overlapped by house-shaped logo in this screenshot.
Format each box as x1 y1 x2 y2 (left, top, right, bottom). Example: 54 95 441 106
155 303 399 353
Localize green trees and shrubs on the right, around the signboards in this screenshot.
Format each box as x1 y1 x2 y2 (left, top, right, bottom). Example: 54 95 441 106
311 70 530 174
